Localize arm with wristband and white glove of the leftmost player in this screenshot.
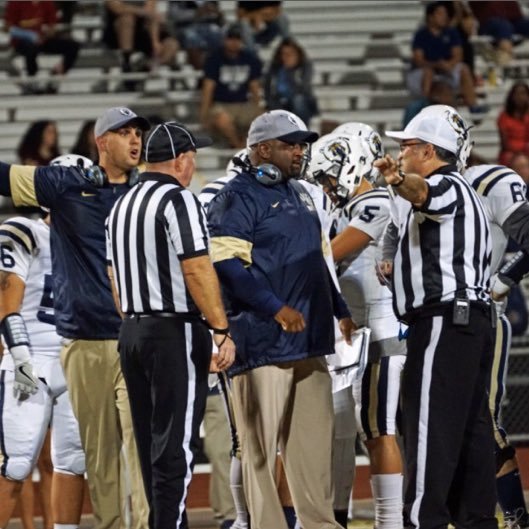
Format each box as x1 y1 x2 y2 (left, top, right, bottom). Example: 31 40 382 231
0 271 38 394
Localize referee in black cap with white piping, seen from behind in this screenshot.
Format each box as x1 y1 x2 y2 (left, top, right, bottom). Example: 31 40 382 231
107 122 235 529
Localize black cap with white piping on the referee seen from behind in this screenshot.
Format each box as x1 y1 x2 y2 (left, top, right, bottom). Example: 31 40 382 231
143 121 213 163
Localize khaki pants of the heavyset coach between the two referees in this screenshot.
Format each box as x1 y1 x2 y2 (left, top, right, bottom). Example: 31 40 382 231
232 358 341 529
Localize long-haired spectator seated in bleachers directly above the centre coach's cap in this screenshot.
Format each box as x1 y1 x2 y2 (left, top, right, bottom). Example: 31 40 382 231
264 37 318 126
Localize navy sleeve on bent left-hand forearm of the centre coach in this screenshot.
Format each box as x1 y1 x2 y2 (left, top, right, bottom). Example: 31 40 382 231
215 258 285 317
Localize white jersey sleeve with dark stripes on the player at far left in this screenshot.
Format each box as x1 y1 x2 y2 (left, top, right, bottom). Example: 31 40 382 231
0 217 37 283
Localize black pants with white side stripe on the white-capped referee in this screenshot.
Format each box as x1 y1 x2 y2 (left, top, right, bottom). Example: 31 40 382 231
401 304 498 529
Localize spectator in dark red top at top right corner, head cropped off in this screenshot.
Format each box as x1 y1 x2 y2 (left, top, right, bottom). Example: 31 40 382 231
469 0 529 66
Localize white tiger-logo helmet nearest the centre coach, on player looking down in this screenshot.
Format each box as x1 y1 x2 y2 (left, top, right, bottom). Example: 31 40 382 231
309 133 371 206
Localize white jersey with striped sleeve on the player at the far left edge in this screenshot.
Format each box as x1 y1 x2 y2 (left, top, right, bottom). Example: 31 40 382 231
0 217 61 359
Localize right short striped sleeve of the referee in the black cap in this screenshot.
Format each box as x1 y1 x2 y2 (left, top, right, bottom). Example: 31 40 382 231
164 190 209 260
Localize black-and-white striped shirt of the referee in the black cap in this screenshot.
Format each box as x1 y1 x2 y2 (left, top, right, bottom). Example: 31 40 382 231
106 173 208 314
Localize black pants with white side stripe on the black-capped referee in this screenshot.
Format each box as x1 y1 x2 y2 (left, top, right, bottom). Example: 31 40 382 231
119 316 211 529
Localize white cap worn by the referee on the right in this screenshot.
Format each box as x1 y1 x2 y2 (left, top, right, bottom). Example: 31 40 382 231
386 105 469 154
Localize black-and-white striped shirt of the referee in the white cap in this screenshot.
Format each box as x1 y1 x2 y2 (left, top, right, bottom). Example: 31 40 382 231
391 165 492 317
